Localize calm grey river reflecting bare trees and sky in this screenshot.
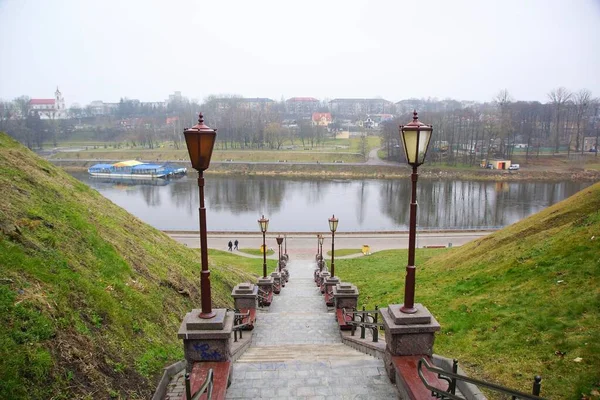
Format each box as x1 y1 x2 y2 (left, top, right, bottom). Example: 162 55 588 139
72 172 589 232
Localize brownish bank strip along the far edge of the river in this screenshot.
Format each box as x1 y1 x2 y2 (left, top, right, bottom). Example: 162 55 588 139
48 159 600 182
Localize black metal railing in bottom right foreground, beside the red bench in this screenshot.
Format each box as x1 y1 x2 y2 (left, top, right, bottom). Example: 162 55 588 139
417 358 544 400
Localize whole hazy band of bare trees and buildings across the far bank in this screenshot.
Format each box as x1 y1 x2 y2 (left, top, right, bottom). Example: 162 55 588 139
0 87 600 161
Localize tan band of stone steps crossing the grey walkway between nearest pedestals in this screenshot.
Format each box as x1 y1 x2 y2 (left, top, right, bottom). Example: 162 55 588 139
237 343 373 363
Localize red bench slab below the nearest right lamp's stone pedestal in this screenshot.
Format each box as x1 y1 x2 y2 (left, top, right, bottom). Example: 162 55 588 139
392 355 448 400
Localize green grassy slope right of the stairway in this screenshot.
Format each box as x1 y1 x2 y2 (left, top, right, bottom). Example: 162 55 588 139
336 184 600 399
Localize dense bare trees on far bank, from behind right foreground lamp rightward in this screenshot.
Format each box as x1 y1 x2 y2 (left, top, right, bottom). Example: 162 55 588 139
381 87 600 165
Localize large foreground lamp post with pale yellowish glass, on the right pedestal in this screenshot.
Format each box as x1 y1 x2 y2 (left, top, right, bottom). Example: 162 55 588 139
400 110 433 314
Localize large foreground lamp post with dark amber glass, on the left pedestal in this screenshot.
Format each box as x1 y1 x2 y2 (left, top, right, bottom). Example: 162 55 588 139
183 113 217 319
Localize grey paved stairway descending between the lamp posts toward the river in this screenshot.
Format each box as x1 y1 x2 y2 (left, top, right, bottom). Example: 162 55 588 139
227 261 398 400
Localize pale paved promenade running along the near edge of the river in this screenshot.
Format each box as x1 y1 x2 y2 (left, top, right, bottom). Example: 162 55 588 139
165 231 493 259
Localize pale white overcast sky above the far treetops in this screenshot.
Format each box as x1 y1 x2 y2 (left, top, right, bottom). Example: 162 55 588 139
0 0 600 105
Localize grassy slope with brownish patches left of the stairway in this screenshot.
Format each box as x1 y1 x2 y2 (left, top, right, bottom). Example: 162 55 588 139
0 133 262 399
